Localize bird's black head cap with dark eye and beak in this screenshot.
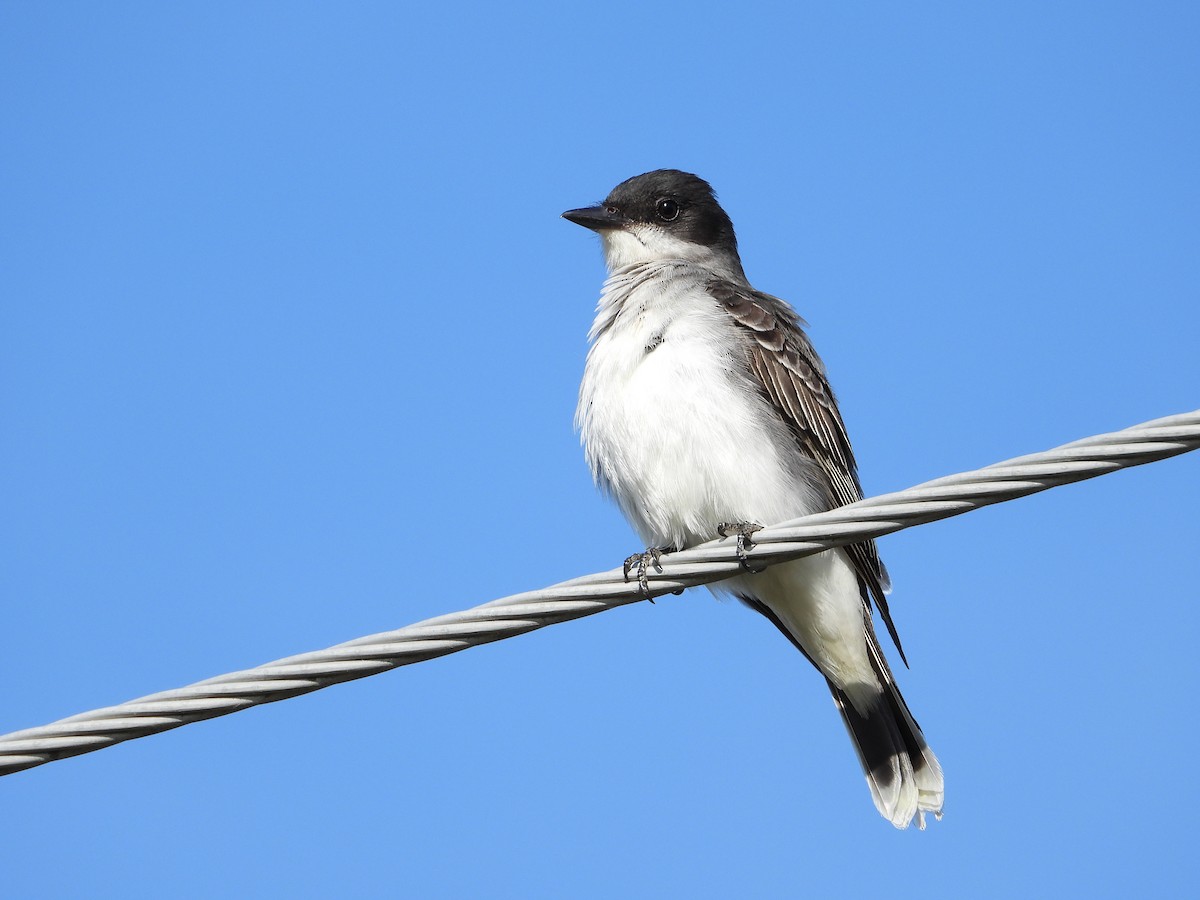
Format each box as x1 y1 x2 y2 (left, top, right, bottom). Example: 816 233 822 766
563 169 738 257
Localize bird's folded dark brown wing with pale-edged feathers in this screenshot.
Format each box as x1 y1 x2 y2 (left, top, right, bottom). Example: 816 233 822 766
708 281 908 665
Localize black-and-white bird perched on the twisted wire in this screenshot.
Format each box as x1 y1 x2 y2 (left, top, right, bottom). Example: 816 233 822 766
563 169 944 829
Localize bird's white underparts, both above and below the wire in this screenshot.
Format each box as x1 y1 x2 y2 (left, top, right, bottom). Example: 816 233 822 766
576 264 875 696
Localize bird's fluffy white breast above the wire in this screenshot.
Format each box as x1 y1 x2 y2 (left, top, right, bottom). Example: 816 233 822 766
576 262 820 547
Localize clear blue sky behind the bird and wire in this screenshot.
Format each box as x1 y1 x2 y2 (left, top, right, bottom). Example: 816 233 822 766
0 2 1200 898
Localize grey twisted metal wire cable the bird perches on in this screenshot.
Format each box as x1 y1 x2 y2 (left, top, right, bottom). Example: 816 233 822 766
0 410 1200 775
